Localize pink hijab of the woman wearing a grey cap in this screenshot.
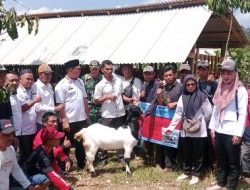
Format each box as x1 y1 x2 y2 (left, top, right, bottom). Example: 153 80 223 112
213 72 243 123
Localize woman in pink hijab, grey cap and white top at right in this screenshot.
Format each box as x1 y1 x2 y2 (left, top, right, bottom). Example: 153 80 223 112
207 59 248 190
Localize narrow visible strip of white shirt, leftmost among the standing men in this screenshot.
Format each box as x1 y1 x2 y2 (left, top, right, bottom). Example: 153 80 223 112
10 95 22 136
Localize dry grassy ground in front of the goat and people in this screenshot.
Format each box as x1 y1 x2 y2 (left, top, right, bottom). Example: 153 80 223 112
69 151 250 190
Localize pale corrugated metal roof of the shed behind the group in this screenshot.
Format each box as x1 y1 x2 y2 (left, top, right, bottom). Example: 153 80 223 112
0 6 212 65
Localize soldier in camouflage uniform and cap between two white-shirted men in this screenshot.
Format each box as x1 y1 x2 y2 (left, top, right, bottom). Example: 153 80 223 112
82 60 102 125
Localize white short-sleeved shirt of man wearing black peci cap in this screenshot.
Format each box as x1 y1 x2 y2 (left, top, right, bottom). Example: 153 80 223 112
55 77 87 123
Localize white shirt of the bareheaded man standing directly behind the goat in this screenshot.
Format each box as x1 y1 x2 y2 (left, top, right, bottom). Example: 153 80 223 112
94 75 125 118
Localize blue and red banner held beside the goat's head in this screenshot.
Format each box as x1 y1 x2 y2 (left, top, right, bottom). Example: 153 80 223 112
139 102 180 148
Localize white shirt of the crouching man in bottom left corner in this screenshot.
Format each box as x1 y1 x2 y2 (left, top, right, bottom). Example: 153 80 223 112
0 146 30 190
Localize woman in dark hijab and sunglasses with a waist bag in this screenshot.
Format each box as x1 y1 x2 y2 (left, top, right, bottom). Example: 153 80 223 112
167 75 212 185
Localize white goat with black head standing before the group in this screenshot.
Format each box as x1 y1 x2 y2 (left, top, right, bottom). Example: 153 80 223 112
75 106 141 177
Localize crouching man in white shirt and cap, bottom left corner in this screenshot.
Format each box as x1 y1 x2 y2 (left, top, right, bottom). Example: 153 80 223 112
0 119 35 190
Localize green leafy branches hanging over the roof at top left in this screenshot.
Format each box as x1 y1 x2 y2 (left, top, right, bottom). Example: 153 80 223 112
0 0 38 40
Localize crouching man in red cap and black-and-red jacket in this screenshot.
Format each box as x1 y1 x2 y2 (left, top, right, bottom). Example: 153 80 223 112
27 127 71 190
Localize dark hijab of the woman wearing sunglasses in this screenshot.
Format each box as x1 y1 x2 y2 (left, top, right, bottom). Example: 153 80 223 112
182 74 207 119
